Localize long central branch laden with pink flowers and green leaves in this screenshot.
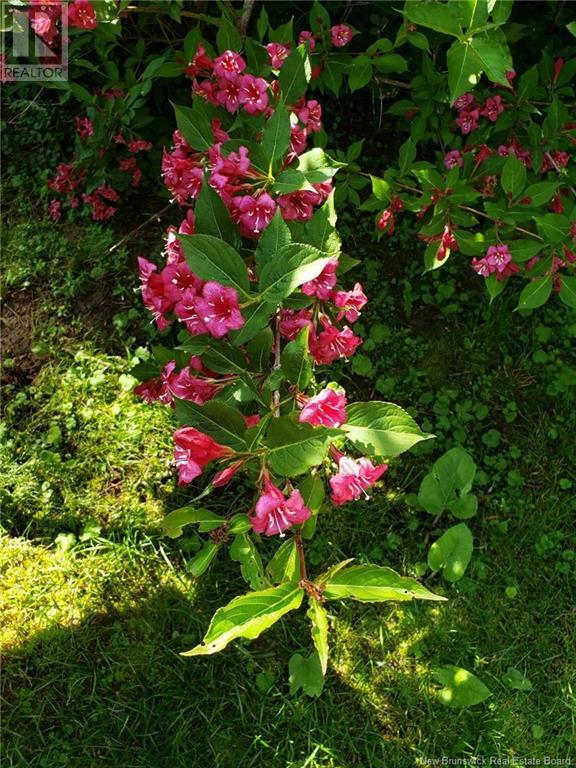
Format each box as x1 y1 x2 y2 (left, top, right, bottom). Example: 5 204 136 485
134 39 443 674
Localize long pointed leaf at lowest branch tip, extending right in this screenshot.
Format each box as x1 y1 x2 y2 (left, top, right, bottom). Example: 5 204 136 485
324 564 446 603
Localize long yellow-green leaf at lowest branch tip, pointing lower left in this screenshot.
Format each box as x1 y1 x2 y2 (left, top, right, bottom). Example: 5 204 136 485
181 584 304 656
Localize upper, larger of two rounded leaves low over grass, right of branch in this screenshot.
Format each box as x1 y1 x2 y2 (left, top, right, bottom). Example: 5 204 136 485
418 447 476 515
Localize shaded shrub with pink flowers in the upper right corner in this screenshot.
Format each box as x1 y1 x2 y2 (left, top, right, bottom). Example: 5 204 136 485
364 2 576 309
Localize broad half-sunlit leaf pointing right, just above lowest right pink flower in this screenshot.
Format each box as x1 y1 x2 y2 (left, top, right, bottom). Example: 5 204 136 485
342 400 434 458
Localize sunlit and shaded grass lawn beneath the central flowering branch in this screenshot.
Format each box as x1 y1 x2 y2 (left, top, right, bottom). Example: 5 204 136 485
0 206 576 768
